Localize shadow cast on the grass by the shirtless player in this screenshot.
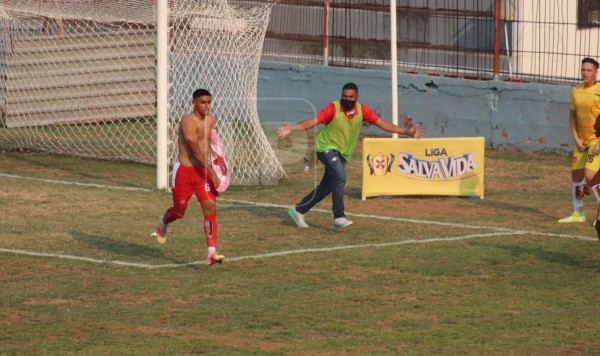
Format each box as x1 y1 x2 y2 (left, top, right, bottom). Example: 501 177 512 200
71 231 198 269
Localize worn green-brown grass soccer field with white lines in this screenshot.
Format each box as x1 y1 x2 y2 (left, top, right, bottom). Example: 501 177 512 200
0 148 600 355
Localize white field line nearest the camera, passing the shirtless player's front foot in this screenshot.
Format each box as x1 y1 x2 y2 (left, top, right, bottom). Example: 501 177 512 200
0 232 527 269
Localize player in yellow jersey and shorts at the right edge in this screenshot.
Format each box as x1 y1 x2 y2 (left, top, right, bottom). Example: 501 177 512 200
558 58 600 223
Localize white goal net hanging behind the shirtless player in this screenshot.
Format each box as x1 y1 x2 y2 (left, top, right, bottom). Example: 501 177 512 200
0 0 285 185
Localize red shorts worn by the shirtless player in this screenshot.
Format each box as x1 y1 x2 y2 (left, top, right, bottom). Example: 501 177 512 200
173 162 219 210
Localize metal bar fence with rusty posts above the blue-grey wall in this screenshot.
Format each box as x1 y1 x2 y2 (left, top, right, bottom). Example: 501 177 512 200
235 0 600 84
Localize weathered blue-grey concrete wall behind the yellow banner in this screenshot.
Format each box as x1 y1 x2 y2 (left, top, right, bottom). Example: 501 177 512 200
258 62 572 153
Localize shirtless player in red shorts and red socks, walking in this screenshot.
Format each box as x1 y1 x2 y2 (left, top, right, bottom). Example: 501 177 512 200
156 89 225 265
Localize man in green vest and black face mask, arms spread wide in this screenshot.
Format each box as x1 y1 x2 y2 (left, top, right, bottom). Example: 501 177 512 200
277 83 423 229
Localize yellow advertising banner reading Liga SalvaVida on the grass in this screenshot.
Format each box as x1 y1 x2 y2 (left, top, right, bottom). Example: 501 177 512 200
362 137 485 200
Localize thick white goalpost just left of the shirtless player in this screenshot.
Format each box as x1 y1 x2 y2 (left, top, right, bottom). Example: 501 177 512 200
156 0 169 189
